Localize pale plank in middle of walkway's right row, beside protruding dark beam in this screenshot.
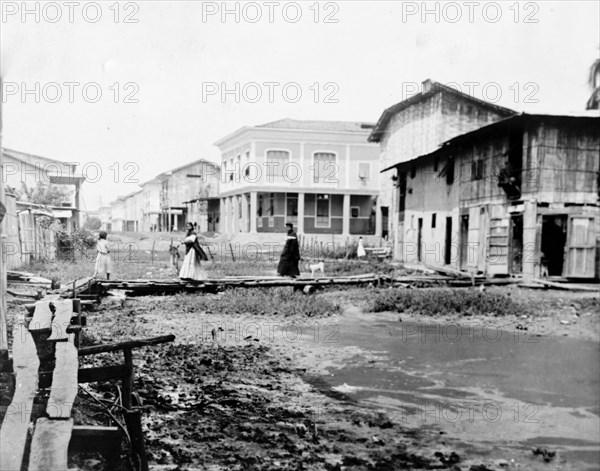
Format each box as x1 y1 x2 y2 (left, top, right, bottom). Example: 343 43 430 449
46 340 79 419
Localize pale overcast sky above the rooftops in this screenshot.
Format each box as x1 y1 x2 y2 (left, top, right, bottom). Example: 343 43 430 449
1 1 600 209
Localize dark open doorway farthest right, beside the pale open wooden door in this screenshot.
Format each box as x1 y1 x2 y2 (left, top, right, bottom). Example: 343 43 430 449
541 214 567 276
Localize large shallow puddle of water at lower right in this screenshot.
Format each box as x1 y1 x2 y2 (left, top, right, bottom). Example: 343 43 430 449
300 318 600 467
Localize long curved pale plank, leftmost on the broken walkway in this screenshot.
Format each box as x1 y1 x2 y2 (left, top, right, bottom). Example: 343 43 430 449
0 324 40 470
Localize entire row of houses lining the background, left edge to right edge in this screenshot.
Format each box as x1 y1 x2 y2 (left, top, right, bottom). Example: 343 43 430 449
3 80 600 279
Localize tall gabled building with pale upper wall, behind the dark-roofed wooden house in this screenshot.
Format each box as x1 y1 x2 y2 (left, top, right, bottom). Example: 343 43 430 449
369 80 516 259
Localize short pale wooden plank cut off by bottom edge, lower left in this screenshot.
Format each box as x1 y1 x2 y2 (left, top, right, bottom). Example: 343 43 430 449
29 419 73 471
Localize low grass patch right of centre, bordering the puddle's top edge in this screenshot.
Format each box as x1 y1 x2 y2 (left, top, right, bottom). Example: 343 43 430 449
367 288 530 316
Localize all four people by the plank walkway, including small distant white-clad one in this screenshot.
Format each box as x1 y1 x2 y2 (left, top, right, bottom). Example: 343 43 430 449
94 222 366 281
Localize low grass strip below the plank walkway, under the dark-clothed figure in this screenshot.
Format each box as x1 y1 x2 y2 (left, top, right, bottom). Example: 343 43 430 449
141 288 342 317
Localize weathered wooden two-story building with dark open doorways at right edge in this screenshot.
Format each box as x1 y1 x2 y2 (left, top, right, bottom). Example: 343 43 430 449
380 113 600 278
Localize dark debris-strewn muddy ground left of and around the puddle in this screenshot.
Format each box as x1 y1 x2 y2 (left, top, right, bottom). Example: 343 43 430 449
2 288 600 471
